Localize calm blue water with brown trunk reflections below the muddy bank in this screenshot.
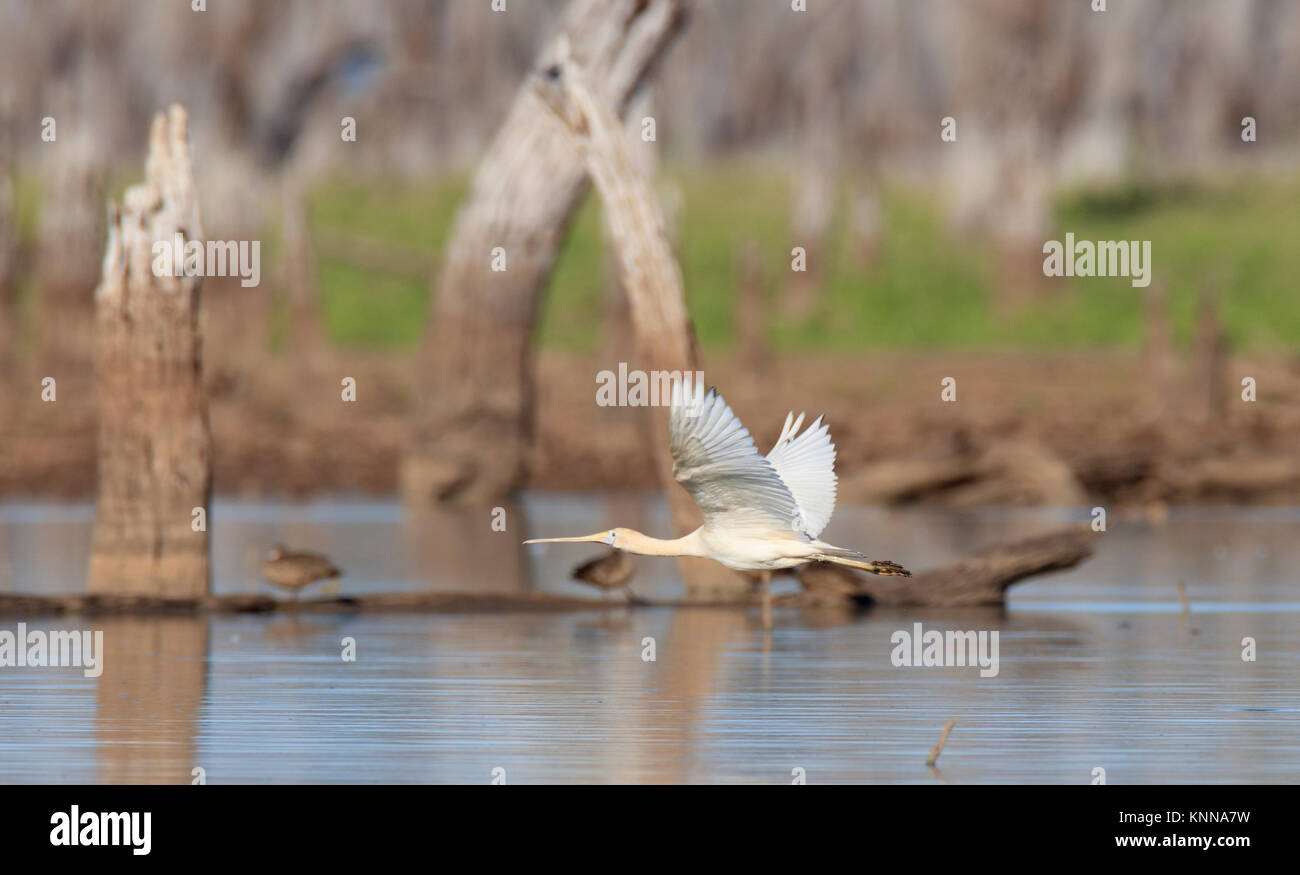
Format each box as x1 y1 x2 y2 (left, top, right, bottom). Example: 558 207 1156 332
0 495 1300 784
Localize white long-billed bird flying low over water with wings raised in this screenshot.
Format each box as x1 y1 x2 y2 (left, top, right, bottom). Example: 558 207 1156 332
524 382 911 608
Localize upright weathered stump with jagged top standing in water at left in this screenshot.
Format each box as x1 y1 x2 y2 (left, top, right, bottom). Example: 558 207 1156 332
90 105 212 599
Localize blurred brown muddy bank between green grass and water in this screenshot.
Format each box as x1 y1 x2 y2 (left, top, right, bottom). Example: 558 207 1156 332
0 338 1300 501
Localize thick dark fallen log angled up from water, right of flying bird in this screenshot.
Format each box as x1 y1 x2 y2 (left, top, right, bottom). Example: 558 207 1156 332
788 525 1096 607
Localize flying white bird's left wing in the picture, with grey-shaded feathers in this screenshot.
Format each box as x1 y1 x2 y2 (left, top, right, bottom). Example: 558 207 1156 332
668 382 810 540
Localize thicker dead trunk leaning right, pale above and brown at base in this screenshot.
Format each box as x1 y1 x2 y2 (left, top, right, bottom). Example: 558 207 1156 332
402 0 686 504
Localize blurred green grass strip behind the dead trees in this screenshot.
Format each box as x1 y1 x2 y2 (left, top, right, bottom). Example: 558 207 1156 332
16 161 1300 352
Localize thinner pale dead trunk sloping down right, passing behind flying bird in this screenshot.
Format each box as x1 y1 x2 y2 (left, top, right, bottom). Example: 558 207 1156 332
536 48 749 594
